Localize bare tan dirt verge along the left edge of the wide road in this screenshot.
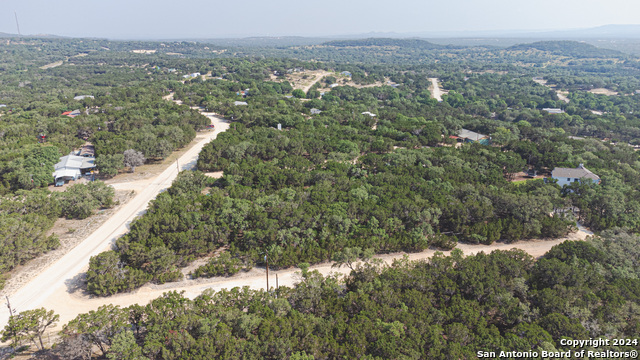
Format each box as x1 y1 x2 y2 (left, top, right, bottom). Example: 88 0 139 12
0 191 135 296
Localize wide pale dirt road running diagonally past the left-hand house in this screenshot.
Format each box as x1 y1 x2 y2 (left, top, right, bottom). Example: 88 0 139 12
0 98 229 328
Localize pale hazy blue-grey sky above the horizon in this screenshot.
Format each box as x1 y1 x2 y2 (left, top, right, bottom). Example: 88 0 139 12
0 0 640 39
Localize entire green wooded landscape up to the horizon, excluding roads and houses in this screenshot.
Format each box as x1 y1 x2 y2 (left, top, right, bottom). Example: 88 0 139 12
0 35 640 359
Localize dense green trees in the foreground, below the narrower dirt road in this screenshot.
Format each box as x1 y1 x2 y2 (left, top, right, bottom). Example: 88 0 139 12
2 231 640 360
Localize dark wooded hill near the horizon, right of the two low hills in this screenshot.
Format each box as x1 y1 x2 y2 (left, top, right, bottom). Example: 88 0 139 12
507 40 625 58
